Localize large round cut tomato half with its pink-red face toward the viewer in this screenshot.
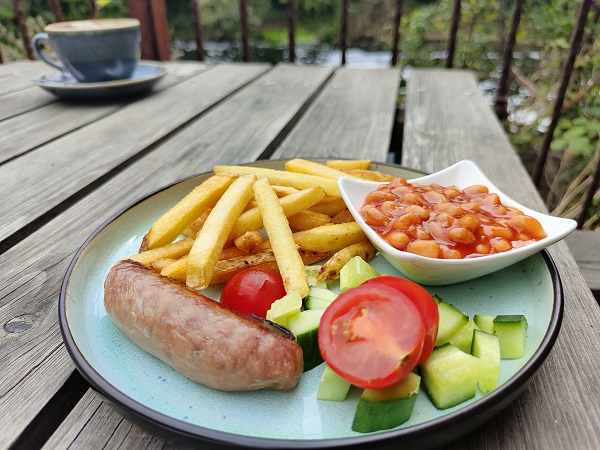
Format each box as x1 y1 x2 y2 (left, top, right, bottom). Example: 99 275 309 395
319 284 425 389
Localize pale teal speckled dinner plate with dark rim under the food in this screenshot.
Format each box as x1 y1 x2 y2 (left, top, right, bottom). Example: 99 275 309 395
59 161 563 448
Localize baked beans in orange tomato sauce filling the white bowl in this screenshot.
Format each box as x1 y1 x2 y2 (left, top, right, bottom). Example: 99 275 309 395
361 177 546 259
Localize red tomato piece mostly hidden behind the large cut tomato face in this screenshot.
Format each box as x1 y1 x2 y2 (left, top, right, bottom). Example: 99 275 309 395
363 275 440 365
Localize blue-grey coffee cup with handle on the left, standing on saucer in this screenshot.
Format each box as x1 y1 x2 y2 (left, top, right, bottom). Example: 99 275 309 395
32 18 141 83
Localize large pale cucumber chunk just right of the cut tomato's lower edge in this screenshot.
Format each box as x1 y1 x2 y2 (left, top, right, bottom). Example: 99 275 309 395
419 344 479 409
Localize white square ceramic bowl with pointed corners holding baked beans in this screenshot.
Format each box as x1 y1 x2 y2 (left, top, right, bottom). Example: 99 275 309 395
338 160 577 286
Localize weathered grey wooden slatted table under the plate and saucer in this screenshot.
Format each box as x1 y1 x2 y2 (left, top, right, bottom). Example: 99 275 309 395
0 62 600 449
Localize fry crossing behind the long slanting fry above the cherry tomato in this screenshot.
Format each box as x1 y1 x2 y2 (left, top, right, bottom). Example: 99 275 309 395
229 186 326 239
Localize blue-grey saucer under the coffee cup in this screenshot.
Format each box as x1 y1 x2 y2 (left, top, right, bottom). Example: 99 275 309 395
33 61 167 99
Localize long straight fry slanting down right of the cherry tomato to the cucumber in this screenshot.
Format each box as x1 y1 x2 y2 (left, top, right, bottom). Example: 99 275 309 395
253 179 308 298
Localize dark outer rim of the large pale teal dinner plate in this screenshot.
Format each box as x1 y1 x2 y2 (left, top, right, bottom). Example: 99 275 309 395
58 159 564 448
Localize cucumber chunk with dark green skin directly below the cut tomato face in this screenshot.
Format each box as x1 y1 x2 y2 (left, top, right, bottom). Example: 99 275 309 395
352 372 421 433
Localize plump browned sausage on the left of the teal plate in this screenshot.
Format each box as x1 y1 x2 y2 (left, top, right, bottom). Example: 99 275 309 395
104 261 303 391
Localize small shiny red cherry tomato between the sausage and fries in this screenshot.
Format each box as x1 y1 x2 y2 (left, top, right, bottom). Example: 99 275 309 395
221 269 286 318
